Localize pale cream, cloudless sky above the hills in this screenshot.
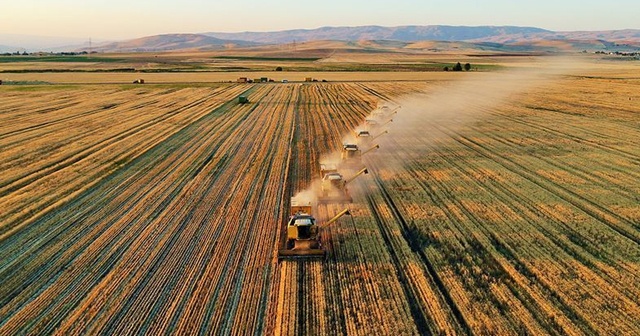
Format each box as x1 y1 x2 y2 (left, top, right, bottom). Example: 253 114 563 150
0 0 640 40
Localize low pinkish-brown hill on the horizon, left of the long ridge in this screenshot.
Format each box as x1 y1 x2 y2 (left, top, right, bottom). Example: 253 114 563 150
93 34 256 52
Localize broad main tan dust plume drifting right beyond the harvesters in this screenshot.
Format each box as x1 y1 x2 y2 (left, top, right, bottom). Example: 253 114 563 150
365 58 581 178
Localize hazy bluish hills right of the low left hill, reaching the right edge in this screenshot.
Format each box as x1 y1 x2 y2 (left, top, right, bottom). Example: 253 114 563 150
205 25 640 51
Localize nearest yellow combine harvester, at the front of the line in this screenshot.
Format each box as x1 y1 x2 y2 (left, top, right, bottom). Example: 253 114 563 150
278 197 351 259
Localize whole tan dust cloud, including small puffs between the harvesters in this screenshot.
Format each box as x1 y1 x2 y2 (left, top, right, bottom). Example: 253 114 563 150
294 58 583 211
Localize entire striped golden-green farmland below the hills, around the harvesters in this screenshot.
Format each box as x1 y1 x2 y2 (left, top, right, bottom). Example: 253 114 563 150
0 42 640 335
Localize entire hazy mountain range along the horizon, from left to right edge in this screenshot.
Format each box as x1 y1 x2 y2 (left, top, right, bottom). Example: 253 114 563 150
0 25 640 52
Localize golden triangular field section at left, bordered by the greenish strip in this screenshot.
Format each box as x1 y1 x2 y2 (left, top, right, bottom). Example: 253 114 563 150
0 86 247 239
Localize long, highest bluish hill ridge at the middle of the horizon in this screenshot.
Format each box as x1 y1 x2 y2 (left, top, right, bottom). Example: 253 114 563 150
204 26 553 44
